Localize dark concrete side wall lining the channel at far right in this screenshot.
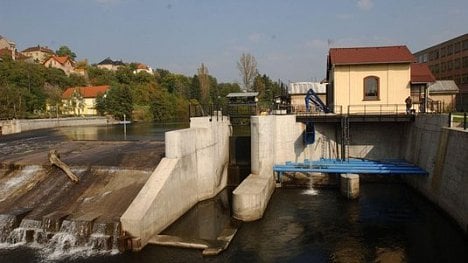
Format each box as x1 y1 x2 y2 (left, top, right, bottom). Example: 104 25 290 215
405 115 468 232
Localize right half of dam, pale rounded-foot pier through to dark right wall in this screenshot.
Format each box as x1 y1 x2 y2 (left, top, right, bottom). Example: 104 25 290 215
233 114 468 235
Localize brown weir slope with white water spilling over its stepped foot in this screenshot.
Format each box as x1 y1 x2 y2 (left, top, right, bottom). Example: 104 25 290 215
0 165 150 260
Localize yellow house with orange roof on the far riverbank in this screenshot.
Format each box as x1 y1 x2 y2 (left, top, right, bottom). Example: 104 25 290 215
62 85 110 115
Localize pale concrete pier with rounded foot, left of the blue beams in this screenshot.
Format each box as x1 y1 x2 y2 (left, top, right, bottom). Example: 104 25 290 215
233 115 303 221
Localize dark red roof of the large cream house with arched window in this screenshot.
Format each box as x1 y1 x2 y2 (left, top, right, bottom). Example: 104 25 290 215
329 46 415 65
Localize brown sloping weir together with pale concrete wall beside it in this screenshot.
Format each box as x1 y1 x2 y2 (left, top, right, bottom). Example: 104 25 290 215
0 117 231 254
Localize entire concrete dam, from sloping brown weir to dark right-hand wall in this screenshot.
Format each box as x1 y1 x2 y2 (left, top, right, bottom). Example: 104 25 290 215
0 114 468 254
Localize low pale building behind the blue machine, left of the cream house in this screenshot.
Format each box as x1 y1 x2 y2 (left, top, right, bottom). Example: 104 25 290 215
288 82 327 112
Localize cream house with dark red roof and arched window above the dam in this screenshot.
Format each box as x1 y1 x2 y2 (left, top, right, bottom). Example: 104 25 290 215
327 46 434 113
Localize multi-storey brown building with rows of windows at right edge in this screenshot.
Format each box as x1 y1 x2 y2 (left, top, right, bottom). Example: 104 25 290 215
414 34 468 111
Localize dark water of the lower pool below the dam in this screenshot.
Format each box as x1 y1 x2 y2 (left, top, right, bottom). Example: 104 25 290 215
0 184 468 263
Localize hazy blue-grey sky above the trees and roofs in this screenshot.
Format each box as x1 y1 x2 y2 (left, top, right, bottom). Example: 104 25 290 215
0 0 468 83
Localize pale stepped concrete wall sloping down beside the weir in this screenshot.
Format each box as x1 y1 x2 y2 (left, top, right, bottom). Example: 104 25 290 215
121 117 231 249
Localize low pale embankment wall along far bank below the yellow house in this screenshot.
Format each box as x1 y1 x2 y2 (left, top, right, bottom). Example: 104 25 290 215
19 117 107 131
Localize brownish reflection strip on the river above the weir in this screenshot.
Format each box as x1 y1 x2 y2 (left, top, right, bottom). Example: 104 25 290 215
59 122 190 141
